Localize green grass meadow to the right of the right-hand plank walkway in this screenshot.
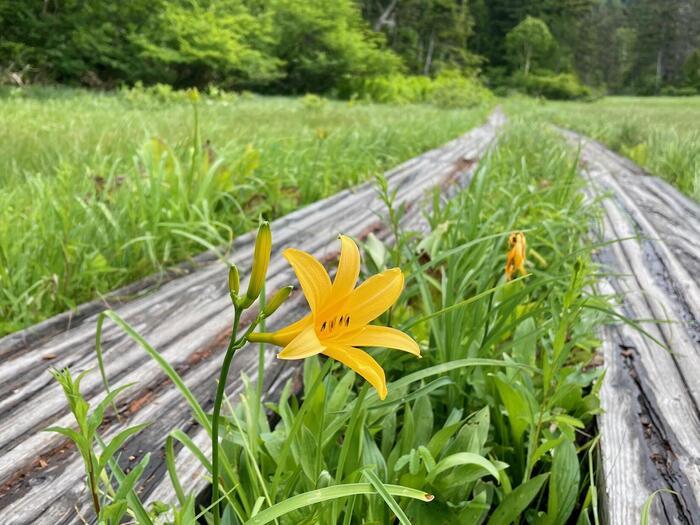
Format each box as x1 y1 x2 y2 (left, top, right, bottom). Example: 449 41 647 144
507 97 700 200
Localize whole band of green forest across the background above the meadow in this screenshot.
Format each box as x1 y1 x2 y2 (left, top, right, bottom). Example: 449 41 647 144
0 0 700 98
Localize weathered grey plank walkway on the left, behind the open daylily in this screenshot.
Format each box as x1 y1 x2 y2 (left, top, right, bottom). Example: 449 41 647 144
0 111 504 525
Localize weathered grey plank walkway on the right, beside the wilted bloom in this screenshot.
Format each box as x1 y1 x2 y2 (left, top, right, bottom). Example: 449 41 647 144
562 130 700 525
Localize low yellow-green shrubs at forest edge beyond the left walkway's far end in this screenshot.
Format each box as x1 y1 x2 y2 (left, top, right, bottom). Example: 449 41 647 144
340 71 493 108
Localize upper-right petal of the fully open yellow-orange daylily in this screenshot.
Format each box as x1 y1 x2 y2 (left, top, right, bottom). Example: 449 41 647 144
343 268 403 327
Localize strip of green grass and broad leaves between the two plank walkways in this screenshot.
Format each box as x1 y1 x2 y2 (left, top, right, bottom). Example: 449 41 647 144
53 118 607 525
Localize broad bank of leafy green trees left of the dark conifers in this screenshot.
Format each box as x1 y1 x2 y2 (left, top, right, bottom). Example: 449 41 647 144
0 0 401 93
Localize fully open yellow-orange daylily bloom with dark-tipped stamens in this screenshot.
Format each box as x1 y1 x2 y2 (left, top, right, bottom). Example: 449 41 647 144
249 235 420 399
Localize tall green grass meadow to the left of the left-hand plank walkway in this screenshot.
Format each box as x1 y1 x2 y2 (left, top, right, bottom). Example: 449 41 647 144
0 88 487 336
